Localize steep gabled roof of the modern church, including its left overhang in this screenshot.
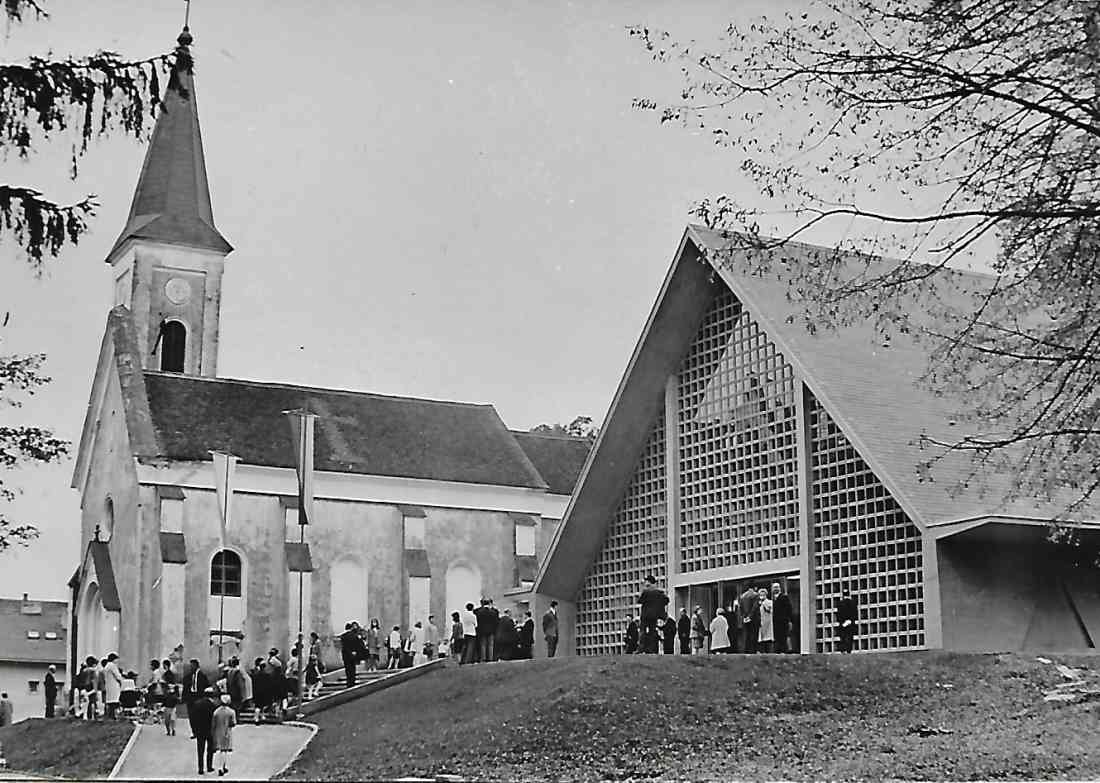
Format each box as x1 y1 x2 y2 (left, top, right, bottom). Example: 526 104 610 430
536 225 1091 599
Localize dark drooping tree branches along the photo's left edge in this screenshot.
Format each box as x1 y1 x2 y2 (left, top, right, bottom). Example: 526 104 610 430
0 0 172 552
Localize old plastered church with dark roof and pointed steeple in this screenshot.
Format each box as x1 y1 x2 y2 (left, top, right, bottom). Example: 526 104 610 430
68 30 590 671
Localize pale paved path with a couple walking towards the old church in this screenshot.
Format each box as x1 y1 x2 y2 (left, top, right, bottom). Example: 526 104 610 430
117 719 311 781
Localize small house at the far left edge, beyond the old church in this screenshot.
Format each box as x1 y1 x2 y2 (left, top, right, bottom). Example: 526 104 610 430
0 593 68 721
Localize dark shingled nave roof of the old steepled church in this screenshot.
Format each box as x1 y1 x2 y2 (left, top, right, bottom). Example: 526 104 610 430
145 372 547 489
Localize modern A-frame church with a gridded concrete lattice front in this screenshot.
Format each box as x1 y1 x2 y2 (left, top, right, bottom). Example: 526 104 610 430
536 227 1100 654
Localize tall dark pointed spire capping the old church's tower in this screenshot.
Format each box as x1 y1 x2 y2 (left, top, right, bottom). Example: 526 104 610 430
108 27 233 261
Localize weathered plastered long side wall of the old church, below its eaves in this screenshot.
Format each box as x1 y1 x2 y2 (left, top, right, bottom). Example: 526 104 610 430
128 486 558 668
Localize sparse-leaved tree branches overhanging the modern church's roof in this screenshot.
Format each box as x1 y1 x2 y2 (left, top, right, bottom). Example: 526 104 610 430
630 0 1100 512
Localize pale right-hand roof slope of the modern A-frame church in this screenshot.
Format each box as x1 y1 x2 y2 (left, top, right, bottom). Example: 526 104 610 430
689 227 1091 522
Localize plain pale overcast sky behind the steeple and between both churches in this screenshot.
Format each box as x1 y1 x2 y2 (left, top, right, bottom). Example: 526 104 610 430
0 0 800 598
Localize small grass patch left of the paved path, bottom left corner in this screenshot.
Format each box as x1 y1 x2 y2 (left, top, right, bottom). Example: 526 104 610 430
0 718 134 780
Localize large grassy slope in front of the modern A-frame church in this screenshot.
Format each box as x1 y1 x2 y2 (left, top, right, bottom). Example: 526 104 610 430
283 652 1100 781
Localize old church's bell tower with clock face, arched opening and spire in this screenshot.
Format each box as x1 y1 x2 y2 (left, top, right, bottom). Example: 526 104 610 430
107 26 233 377
